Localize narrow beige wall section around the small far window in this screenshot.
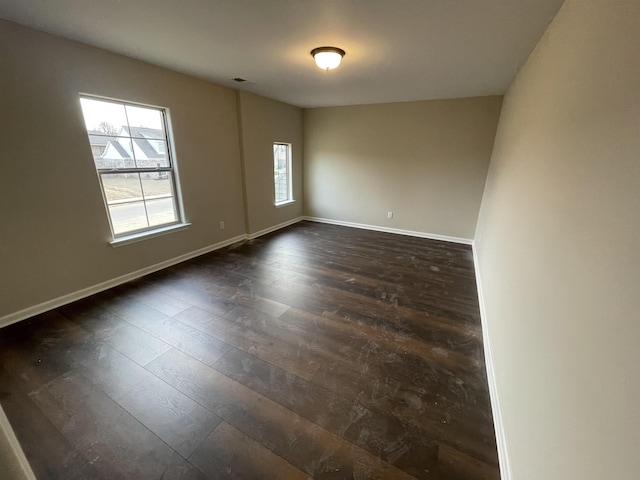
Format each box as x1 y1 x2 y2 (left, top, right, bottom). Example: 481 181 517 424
238 91 303 234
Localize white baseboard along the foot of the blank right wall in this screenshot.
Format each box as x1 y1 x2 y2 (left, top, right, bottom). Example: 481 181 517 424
472 245 511 480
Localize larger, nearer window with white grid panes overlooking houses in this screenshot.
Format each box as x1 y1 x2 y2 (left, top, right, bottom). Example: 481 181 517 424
80 96 182 239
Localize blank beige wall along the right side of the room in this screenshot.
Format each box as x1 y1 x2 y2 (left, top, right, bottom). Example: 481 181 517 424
476 0 640 480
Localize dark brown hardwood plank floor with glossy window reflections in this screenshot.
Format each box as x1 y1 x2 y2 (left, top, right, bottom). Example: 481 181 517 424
0 222 499 480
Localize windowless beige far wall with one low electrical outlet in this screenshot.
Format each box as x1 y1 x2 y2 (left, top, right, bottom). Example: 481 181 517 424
304 96 502 239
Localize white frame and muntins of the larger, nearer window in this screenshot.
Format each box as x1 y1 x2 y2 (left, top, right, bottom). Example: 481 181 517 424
79 93 190 247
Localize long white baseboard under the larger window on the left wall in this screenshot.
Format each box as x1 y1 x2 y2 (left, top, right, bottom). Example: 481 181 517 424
0 234 248 328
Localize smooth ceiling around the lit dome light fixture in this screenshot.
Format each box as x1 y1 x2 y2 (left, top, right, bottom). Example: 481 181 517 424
0 0 562 107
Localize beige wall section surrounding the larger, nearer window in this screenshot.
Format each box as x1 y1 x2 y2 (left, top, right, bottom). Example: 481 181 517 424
0 21 245 318
